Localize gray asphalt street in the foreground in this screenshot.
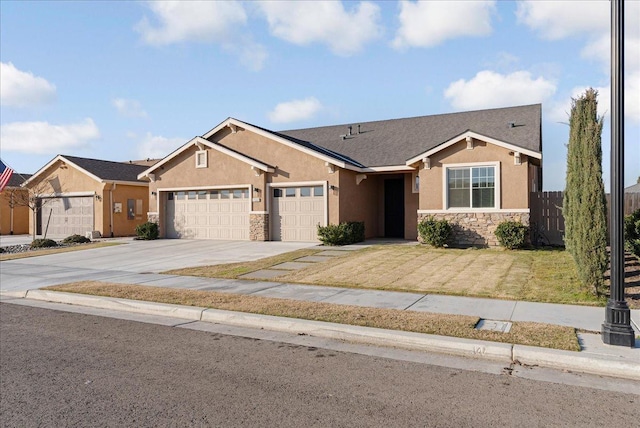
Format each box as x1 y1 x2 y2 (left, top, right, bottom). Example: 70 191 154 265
0 304 640 427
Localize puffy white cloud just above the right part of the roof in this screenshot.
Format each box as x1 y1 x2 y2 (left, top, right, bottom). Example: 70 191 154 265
444 70 556 110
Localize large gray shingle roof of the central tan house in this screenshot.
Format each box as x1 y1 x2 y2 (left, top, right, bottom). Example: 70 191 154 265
278 104 542 167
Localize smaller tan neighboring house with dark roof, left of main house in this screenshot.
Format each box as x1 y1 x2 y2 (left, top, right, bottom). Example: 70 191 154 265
23 155 149 237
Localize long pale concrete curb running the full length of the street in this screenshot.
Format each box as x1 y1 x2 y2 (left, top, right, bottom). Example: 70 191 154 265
0 290 640 380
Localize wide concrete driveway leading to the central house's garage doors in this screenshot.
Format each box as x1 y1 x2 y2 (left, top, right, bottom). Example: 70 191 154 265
0 237 316 291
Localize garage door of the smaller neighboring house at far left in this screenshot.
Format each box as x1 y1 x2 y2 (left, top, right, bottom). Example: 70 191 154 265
39 196 93 236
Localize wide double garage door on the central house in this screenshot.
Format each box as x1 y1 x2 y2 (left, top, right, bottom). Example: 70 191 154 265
166 188 251 240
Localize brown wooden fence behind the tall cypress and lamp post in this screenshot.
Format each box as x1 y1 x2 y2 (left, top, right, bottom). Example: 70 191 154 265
530 192 640 245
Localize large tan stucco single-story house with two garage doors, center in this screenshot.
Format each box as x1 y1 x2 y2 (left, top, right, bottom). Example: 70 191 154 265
138 104 542 245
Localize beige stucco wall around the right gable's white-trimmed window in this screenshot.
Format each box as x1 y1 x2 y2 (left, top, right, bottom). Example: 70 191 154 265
419 140 531 210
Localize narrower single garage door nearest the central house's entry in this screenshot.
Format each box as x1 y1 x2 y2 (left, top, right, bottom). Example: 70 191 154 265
271 186 326 241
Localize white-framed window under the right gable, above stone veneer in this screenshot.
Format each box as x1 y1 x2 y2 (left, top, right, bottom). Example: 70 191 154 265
447 165 498 208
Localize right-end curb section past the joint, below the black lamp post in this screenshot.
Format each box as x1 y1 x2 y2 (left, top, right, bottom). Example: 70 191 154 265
513 345 640 380
